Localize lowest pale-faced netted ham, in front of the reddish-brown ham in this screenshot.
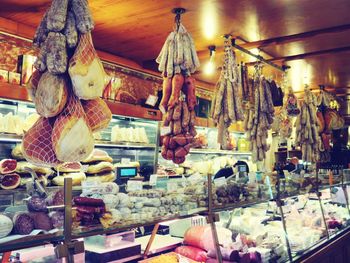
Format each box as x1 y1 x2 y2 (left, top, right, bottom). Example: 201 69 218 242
52 94 94 162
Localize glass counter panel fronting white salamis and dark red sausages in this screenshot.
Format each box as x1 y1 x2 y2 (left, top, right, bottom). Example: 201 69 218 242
69 177 207 240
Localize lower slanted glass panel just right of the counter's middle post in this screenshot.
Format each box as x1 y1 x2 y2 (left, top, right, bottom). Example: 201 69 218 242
216 202 288 262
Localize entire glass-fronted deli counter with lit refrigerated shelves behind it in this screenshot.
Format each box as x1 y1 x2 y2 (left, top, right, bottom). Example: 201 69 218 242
0 93 350 262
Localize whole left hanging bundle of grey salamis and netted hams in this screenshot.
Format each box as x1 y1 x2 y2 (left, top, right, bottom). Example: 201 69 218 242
23 0 111 167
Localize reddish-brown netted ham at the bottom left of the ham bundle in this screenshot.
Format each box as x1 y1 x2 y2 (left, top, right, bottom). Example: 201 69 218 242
22 117 59 166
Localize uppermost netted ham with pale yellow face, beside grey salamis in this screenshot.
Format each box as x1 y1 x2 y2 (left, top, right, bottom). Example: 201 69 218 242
68 33 105 100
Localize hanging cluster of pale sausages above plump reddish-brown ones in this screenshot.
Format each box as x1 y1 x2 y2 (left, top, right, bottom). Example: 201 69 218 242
156 13 199 164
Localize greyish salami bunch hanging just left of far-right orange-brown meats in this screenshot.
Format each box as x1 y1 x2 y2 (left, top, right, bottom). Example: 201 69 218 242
295 88 320 162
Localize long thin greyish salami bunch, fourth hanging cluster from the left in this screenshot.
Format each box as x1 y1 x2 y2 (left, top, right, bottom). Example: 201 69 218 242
244 69 274 162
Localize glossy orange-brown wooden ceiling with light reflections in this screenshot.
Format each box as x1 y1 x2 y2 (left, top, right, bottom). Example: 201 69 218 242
0 0 350 94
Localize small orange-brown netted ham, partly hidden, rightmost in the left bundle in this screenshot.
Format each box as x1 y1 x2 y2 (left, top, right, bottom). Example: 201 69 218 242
81 98 112 132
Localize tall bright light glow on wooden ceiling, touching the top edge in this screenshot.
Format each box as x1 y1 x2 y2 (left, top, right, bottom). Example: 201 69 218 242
202 1 218 39
